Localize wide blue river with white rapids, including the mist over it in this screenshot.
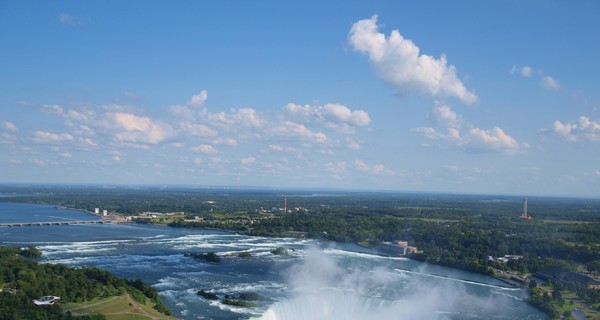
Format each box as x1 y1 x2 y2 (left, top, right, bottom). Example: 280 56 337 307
0 203 547 320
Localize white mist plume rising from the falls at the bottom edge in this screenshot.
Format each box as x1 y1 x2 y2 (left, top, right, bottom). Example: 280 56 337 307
253 249 464 320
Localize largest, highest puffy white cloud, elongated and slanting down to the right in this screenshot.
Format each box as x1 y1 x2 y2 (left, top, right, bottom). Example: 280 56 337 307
348 15 478 104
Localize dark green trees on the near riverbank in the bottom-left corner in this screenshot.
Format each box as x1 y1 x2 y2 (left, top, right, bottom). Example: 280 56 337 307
0 247 170 320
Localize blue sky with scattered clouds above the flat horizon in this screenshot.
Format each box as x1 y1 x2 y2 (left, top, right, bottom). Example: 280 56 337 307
0 1 600 197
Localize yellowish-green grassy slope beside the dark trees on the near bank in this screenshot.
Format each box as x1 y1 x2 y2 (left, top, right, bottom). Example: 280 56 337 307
62 294 177 320
